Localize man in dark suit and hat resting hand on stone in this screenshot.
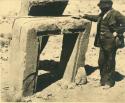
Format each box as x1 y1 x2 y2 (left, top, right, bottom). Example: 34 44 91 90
79 0 125 88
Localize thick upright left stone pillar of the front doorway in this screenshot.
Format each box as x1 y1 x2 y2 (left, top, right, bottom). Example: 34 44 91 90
9 24 38 101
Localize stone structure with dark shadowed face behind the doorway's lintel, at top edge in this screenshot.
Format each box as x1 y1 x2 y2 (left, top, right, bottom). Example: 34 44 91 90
20 0 69 16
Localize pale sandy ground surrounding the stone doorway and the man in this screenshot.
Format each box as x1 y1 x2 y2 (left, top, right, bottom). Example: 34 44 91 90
0 0 125 103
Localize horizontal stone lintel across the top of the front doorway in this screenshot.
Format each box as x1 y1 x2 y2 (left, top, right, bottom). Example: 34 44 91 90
13 16 89 35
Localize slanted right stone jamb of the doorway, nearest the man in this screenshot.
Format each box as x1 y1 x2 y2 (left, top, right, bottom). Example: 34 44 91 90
62 23 91 82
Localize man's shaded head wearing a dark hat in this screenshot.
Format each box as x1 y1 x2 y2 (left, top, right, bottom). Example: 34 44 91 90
98 0 113 12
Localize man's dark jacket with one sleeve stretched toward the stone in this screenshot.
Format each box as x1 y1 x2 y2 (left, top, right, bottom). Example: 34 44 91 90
84 9 125 48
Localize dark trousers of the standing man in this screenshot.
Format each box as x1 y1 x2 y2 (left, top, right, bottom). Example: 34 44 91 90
98 38 117 87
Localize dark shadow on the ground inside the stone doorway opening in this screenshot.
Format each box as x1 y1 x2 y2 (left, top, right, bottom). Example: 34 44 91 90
36 60 60 92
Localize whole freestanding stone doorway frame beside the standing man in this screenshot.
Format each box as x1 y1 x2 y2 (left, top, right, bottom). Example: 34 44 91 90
10 17 91 100
